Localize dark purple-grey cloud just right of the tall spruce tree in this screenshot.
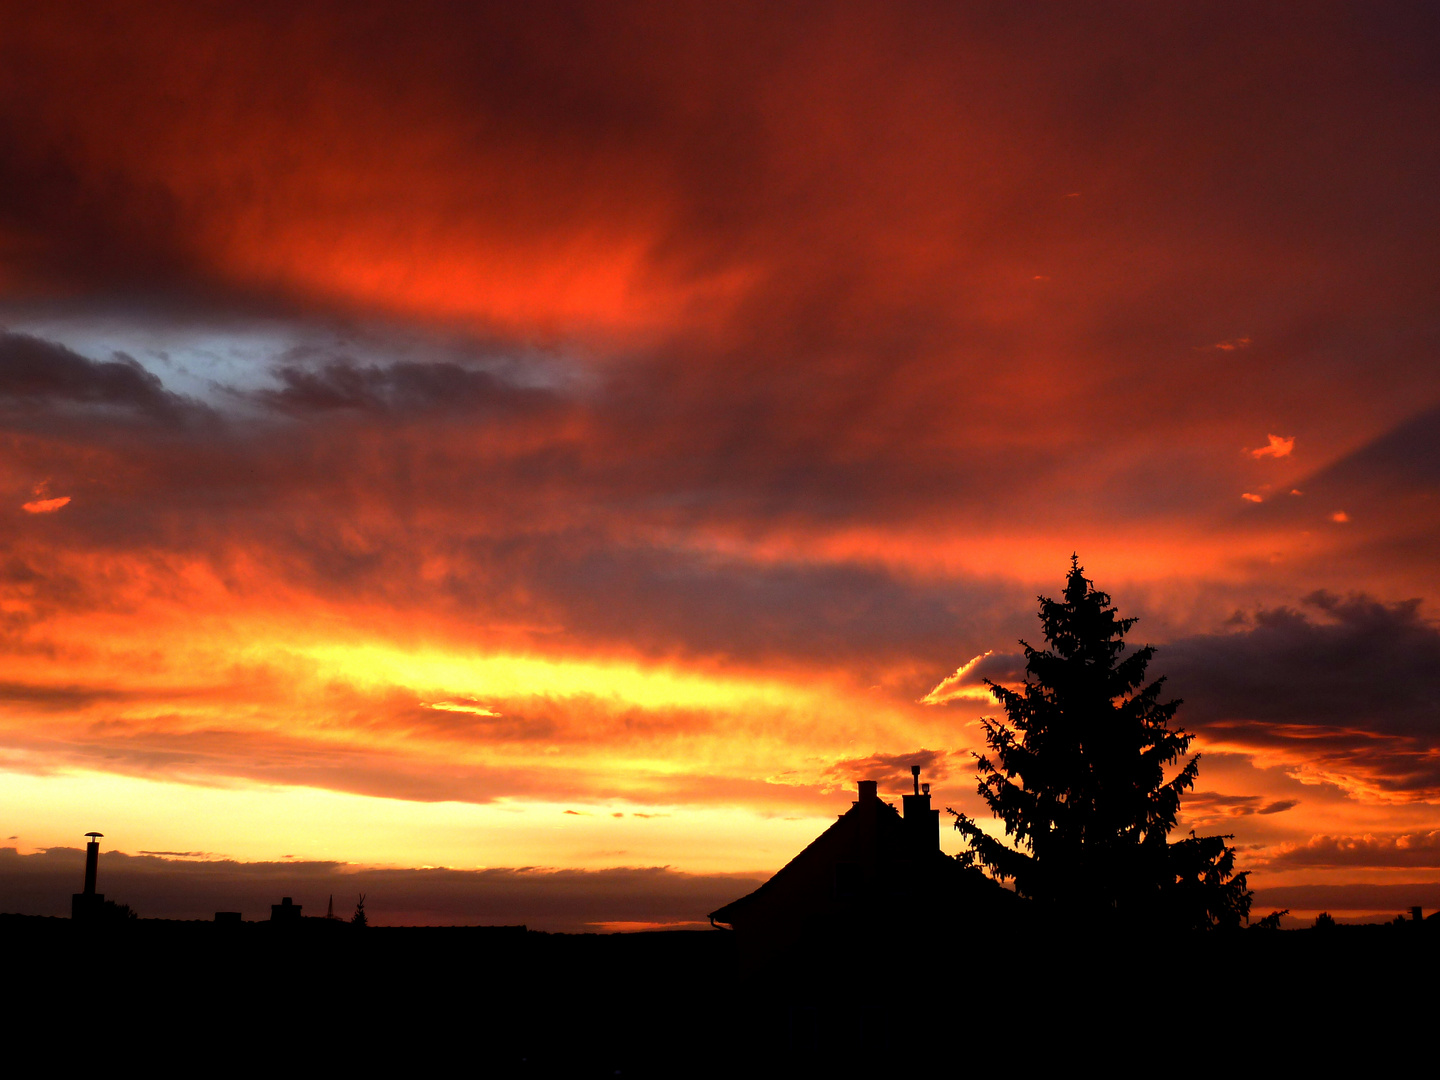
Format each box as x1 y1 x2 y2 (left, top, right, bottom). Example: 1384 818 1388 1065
1156 592 1440 795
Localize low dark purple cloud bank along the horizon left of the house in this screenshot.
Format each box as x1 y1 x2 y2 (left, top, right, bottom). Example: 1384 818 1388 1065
0 848 759 932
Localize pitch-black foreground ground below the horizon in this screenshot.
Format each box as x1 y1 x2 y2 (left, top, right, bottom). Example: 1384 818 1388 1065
0 916 1440 1077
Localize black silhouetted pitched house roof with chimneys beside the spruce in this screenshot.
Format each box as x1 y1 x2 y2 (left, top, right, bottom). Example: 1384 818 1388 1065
710 769 1014 959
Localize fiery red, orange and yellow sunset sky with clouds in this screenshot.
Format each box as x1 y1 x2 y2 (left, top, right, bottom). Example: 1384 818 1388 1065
0 1 1440 924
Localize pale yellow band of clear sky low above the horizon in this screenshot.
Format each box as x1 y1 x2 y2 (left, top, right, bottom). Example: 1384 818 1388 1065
0 769 848 873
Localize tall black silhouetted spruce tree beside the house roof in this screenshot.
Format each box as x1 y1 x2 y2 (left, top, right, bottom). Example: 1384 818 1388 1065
950 557 1250 929
